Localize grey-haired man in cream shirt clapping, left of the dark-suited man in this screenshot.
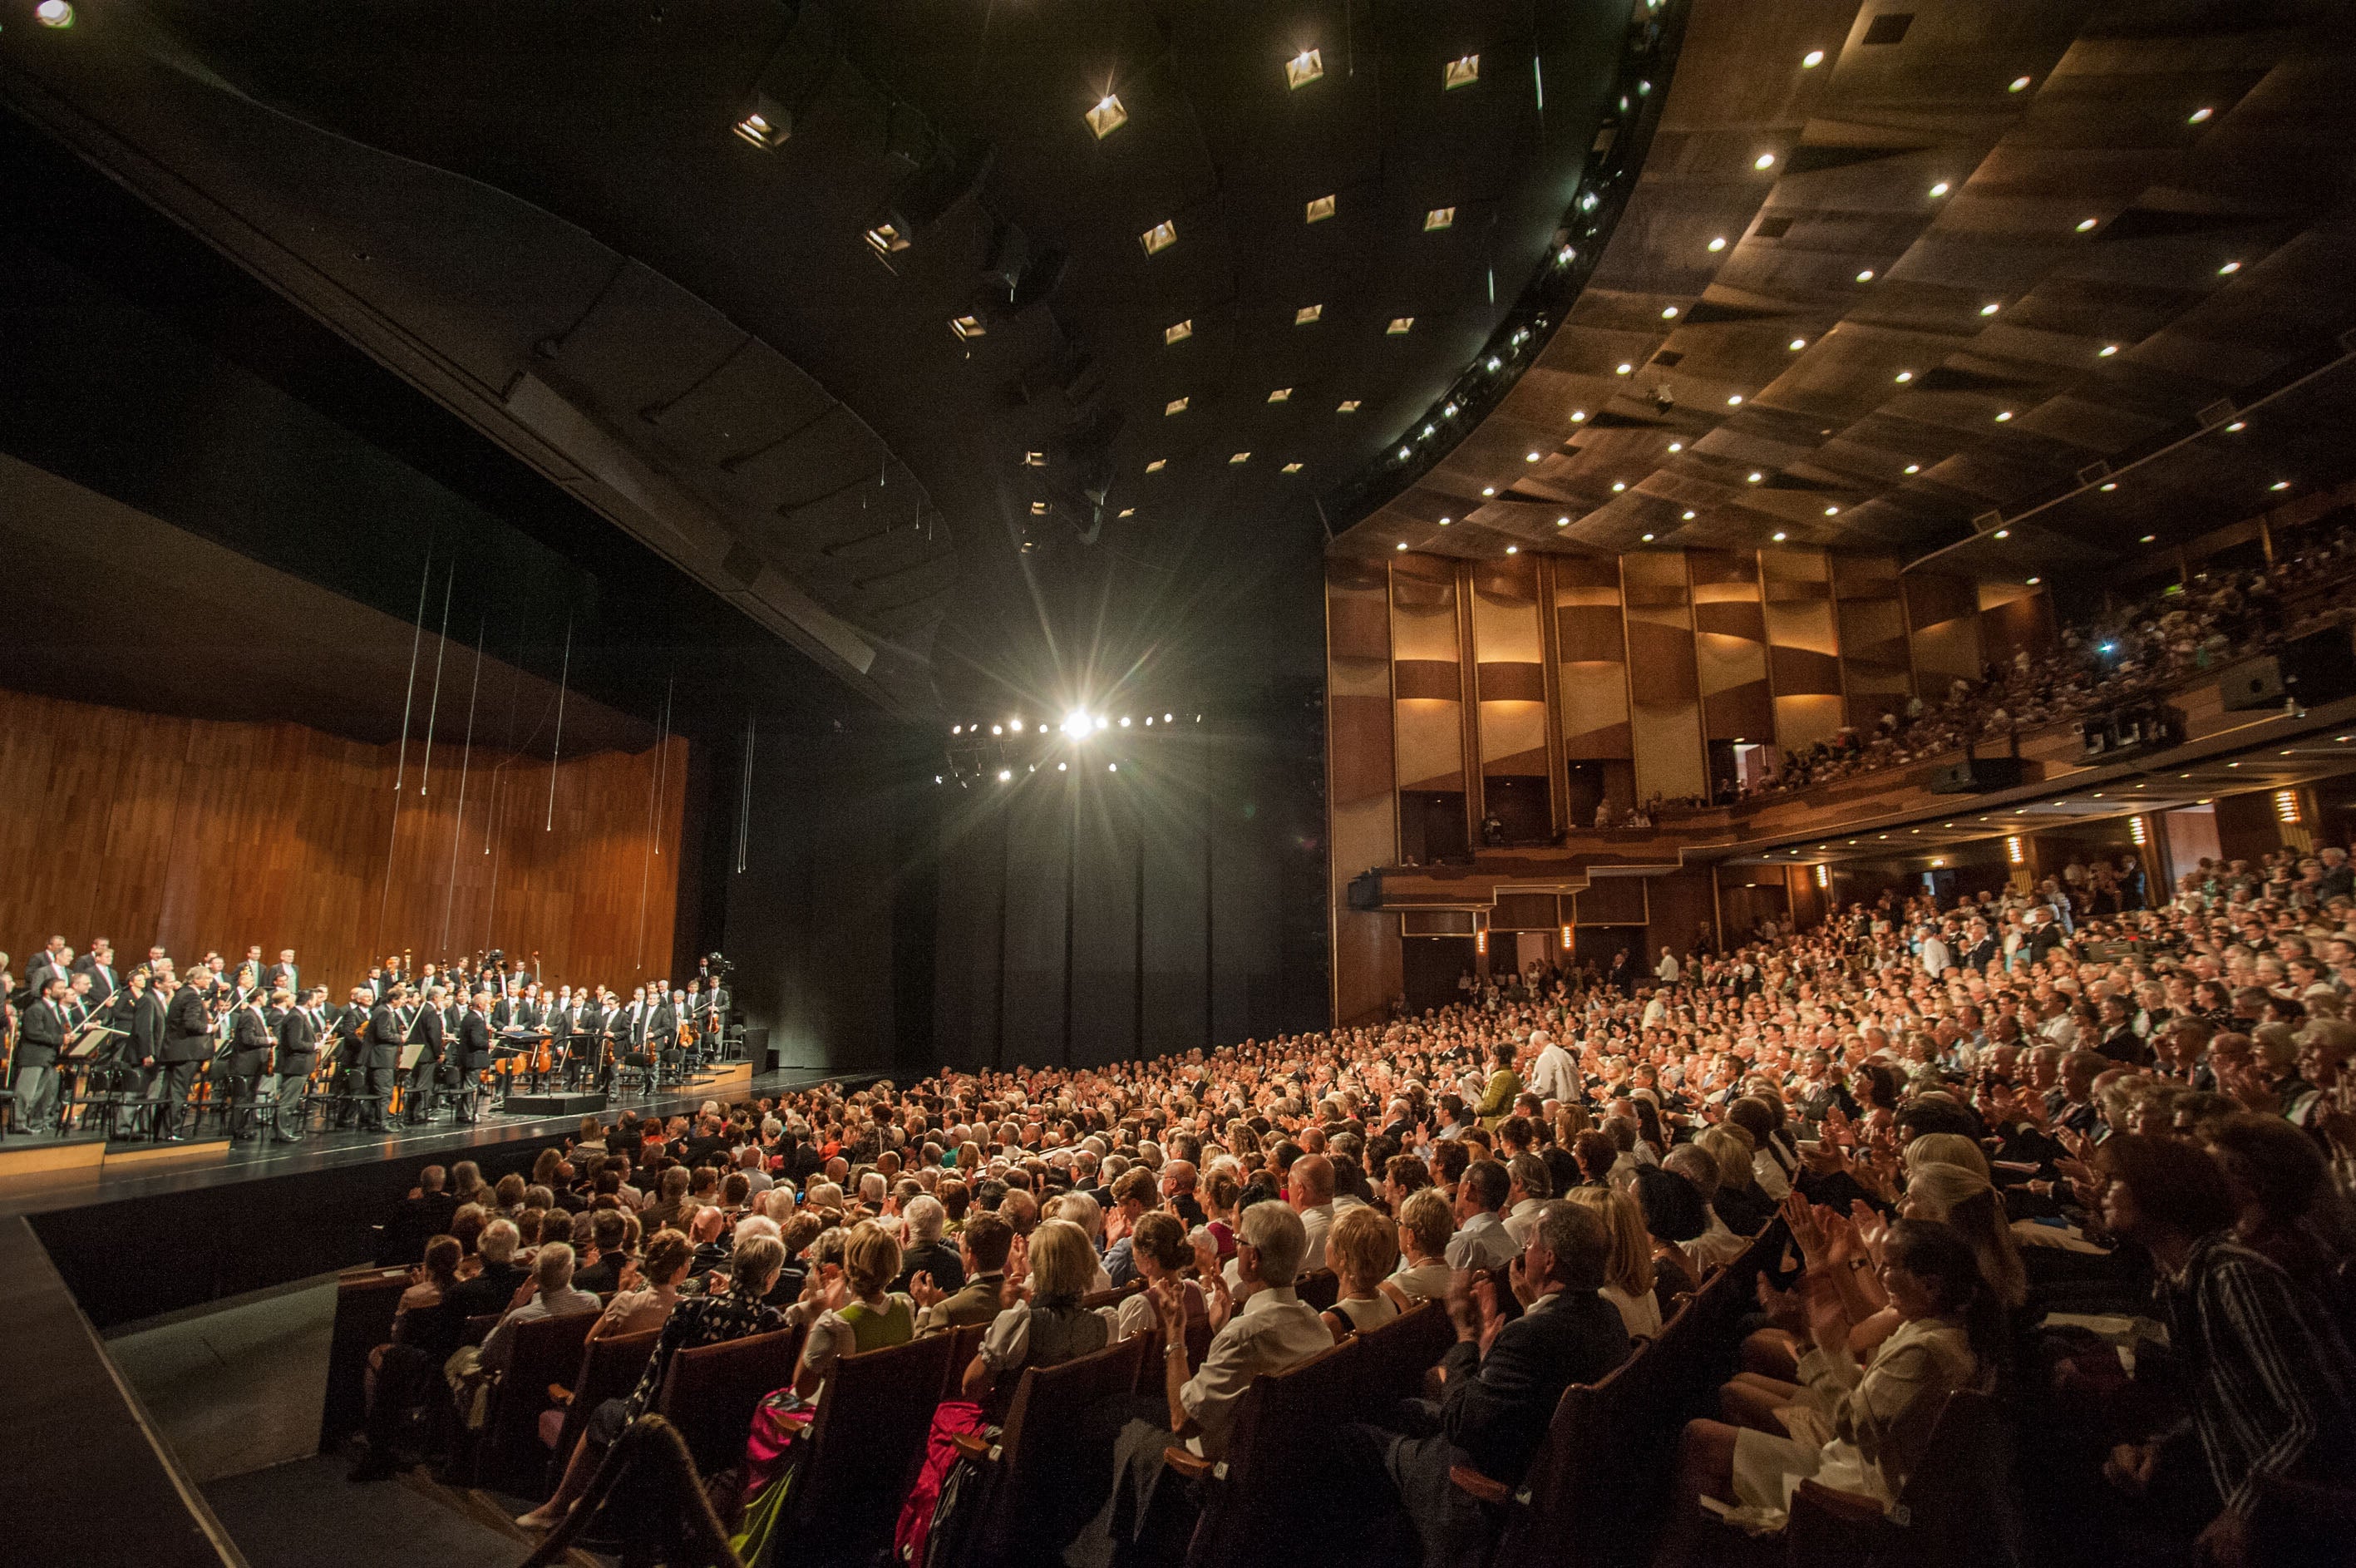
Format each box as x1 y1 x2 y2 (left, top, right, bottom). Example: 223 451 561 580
1062 1202 1348 1568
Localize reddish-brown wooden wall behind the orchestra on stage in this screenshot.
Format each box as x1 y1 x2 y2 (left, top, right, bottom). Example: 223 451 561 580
0 691 688 998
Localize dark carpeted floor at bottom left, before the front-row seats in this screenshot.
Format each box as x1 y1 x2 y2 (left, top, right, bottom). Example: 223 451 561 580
205 1457 596 1568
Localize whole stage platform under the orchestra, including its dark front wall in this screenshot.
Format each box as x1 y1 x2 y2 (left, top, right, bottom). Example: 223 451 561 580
0 1063 881 1328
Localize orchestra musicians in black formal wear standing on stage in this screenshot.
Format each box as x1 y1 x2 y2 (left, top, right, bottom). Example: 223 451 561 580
0 936 732 1144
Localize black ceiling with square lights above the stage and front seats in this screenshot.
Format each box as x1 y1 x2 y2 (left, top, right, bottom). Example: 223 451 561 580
0 0 1630 714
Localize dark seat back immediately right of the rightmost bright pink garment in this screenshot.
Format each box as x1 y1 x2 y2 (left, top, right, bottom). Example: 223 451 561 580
973 1334 1159 1568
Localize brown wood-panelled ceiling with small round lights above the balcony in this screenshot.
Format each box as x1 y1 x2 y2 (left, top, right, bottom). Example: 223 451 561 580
1341 0 2356 580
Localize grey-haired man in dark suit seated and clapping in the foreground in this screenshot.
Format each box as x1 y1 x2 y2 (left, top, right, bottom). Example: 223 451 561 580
1350 1201 1628 1568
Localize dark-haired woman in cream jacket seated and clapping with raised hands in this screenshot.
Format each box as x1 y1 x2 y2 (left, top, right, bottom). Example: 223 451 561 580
1654 1219 2000 1568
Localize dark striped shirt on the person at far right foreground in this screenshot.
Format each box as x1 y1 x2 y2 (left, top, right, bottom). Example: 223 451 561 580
2161 1230 2356 1514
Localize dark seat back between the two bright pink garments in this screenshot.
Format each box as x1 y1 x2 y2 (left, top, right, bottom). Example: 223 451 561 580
780 1334 957 1559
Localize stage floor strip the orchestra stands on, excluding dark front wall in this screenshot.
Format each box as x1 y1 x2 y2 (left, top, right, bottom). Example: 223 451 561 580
0 1071 857 1216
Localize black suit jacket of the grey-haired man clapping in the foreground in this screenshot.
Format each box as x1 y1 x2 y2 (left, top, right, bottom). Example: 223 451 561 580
1440 1289 1628 1486
